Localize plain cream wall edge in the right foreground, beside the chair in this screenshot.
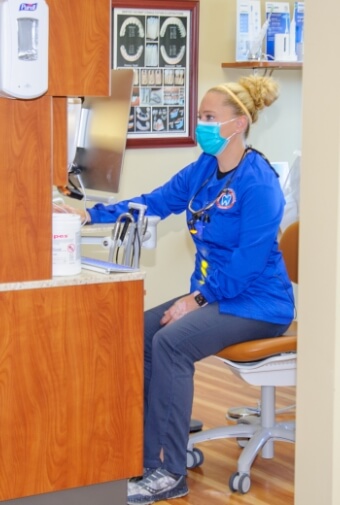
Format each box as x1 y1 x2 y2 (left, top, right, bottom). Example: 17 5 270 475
295 0 340 505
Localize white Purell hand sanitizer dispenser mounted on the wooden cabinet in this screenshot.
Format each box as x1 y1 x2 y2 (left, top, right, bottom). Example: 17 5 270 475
0 0 48 99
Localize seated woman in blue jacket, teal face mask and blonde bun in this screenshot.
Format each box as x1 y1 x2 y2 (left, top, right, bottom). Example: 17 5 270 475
64 75 294 504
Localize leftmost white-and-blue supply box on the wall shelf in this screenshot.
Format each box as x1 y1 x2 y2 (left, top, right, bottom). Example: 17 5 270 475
235 0 261 61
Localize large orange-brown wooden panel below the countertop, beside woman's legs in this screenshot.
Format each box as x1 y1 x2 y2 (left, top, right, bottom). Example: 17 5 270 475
0 280 143 501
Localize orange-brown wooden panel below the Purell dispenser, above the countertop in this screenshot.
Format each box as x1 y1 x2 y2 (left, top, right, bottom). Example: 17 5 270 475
0 96 52 282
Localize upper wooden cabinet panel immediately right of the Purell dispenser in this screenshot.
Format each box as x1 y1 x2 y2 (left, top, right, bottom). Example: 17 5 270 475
46 0 112 96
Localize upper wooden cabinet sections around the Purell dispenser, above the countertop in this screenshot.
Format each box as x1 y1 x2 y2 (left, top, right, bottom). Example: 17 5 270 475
0 0 112 282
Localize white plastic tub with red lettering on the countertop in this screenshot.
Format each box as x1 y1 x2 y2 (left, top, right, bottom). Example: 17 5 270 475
52 213 81 276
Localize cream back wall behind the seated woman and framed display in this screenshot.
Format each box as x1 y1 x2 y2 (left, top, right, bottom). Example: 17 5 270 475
72 0 301 308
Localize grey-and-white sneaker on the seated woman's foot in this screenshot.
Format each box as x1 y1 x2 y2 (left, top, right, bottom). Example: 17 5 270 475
127 468 189 505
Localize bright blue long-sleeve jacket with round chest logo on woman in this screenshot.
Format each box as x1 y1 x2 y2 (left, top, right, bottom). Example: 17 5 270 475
88 149 294 324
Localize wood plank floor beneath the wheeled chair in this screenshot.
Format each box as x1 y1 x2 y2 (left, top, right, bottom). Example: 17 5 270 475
170 357 295 505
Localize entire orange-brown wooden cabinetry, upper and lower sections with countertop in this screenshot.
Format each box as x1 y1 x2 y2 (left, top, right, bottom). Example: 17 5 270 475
0 0 144 505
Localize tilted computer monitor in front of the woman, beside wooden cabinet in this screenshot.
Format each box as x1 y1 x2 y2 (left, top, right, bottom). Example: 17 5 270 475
68 69 133 193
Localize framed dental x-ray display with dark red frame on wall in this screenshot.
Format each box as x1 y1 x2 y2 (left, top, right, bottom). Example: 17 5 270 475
112 0 199 148
